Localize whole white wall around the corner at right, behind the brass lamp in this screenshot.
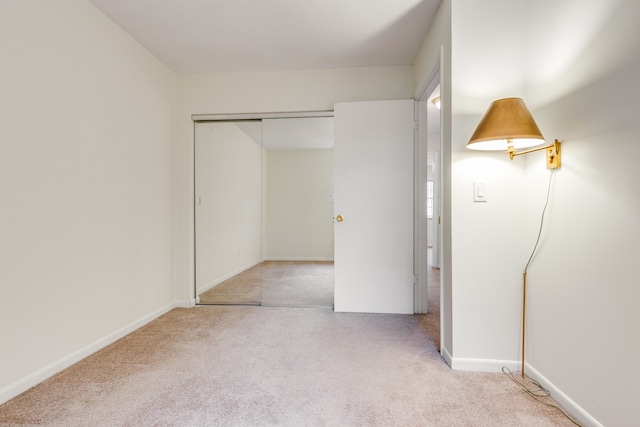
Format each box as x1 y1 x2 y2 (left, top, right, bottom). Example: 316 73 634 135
452 0 640 426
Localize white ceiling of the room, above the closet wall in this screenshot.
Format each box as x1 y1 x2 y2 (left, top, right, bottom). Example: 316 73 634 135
89 0 441 73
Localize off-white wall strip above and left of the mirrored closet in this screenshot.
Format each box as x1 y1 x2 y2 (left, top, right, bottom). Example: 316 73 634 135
174 66 413 300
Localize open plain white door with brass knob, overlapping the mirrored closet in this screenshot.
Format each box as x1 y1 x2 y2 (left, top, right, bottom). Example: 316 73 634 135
334 100 414 313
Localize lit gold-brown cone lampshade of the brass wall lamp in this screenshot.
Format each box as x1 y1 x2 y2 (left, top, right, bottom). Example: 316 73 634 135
467 98 544 151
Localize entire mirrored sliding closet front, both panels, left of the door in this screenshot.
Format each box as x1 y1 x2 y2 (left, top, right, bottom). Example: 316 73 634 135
195 117 333 307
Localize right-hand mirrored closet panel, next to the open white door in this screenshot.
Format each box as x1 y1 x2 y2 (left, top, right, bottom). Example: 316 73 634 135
262 117 334 307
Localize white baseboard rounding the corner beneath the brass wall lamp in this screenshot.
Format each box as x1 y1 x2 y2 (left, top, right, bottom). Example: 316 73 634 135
442 358 603 427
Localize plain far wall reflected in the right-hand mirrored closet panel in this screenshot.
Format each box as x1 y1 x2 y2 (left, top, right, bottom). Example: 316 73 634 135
263 149 333 261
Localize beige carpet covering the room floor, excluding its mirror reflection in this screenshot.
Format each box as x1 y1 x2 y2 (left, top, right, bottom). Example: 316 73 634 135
0 306 573 427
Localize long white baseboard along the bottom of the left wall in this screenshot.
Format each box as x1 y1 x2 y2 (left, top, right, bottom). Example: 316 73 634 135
0 304 178 405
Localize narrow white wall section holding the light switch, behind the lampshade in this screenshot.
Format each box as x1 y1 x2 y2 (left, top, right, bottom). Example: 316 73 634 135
451 0 530 369
